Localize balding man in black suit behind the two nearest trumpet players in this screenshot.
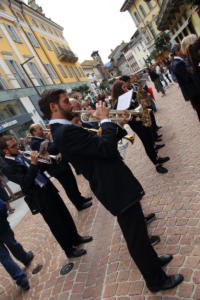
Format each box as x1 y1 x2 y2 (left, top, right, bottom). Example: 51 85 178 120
29 124 92 211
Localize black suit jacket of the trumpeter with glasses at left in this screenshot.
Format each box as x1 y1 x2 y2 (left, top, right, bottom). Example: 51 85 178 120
2 158 57 214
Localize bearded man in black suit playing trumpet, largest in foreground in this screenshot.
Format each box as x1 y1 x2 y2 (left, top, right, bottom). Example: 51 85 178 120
39 89 183 292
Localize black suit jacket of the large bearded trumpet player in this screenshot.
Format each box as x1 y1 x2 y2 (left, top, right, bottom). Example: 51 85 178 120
51 122 144 215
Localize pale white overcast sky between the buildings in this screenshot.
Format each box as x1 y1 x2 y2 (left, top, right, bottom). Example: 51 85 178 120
25 0 136 63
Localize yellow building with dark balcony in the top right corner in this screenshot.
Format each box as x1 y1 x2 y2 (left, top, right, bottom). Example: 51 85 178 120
157 0 200 43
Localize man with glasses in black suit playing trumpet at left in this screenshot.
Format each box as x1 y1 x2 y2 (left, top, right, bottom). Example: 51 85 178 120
0 136 92 257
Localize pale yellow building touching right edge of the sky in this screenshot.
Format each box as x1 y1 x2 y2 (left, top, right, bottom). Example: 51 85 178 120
120 0 162 53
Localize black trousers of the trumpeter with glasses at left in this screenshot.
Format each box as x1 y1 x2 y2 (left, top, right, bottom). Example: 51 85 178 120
40 184 80 255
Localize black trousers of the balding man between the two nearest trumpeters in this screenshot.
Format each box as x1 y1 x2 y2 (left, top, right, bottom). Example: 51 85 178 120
48 164 83 209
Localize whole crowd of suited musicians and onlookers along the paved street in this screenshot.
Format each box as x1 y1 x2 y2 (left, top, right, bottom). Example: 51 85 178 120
0 36 200 292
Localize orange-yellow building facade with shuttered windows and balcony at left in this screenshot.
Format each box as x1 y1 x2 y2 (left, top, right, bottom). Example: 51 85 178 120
0 0 87 137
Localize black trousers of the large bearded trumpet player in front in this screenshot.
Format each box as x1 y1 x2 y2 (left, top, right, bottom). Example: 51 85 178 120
117 203 167 286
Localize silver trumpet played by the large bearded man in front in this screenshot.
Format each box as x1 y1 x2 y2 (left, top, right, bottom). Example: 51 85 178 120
74 105 143 123
